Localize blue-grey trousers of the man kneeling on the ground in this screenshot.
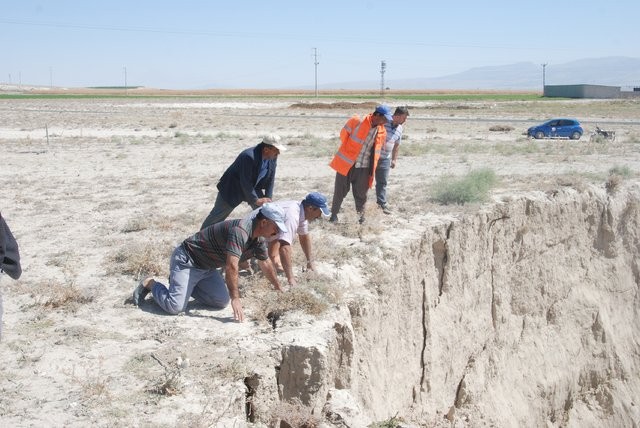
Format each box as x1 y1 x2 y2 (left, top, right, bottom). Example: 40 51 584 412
151 245 229 315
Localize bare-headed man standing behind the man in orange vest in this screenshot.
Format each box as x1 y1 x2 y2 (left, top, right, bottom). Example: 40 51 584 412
376 107 409 214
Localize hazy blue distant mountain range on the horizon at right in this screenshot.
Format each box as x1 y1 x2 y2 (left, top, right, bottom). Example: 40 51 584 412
319 57 640 90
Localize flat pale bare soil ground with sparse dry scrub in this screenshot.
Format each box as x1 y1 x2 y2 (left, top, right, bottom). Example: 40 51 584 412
0 96 640 426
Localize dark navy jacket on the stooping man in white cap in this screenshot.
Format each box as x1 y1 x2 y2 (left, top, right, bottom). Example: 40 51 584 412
218 143 277 207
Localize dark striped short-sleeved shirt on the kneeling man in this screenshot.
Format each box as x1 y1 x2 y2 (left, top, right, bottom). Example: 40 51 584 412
182 218 268 269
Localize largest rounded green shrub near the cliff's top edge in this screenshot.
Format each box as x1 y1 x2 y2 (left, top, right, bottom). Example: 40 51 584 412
432 168 496 205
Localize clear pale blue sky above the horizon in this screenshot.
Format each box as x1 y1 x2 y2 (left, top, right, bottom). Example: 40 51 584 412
0 0 640 89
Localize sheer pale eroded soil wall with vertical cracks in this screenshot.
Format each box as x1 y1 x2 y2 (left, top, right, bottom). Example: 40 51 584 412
330 185 640 426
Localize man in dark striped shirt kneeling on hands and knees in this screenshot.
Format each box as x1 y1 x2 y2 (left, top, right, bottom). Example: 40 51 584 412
133 203 286 321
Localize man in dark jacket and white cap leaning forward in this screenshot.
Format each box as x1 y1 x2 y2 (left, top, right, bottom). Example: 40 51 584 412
200 135 287 230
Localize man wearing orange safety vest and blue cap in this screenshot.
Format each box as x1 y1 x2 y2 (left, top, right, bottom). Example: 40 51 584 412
329 104 392 223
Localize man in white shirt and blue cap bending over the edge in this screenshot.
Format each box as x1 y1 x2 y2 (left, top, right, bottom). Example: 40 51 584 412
255 192 331 286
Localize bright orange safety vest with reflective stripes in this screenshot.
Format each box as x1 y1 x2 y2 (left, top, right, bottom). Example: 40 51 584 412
329 114 387 188
